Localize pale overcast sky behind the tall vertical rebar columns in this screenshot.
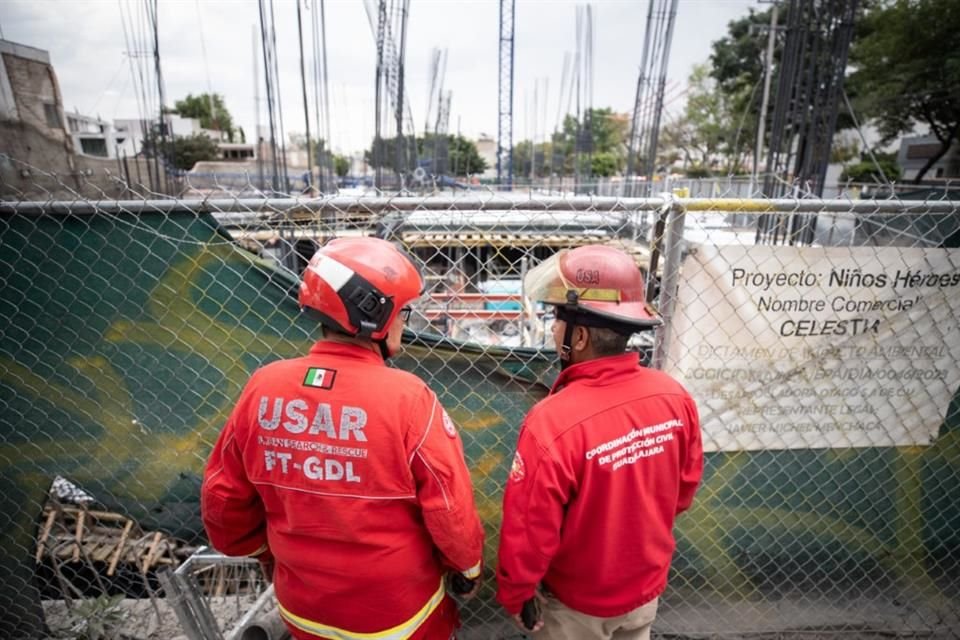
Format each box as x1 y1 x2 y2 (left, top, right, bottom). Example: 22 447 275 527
0 0 763 153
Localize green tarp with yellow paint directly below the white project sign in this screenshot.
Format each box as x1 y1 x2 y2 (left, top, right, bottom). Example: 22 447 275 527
674 438 960 602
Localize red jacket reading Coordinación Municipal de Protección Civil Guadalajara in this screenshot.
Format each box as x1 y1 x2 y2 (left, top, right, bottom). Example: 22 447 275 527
497 353 703 617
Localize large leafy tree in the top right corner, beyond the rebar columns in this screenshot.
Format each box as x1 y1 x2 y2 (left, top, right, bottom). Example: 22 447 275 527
848 0 960 183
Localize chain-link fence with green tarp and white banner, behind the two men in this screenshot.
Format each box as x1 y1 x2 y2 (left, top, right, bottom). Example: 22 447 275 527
0 157 960 639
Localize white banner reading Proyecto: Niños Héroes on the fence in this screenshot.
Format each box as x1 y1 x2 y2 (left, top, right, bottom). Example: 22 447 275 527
667 246 960 451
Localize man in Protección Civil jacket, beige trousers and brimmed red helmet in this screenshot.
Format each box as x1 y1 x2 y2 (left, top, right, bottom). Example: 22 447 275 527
497 246 703 640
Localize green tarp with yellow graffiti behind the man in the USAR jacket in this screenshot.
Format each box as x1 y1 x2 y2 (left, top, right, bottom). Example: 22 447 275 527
0 208 552 636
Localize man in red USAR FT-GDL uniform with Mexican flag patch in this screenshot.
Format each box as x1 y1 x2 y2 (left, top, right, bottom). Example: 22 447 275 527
202 238 483 640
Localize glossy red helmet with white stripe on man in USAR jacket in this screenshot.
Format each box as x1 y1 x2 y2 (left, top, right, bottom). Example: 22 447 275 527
300 238 423 340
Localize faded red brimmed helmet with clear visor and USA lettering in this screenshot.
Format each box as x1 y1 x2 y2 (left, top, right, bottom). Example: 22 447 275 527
524 245 662 331
